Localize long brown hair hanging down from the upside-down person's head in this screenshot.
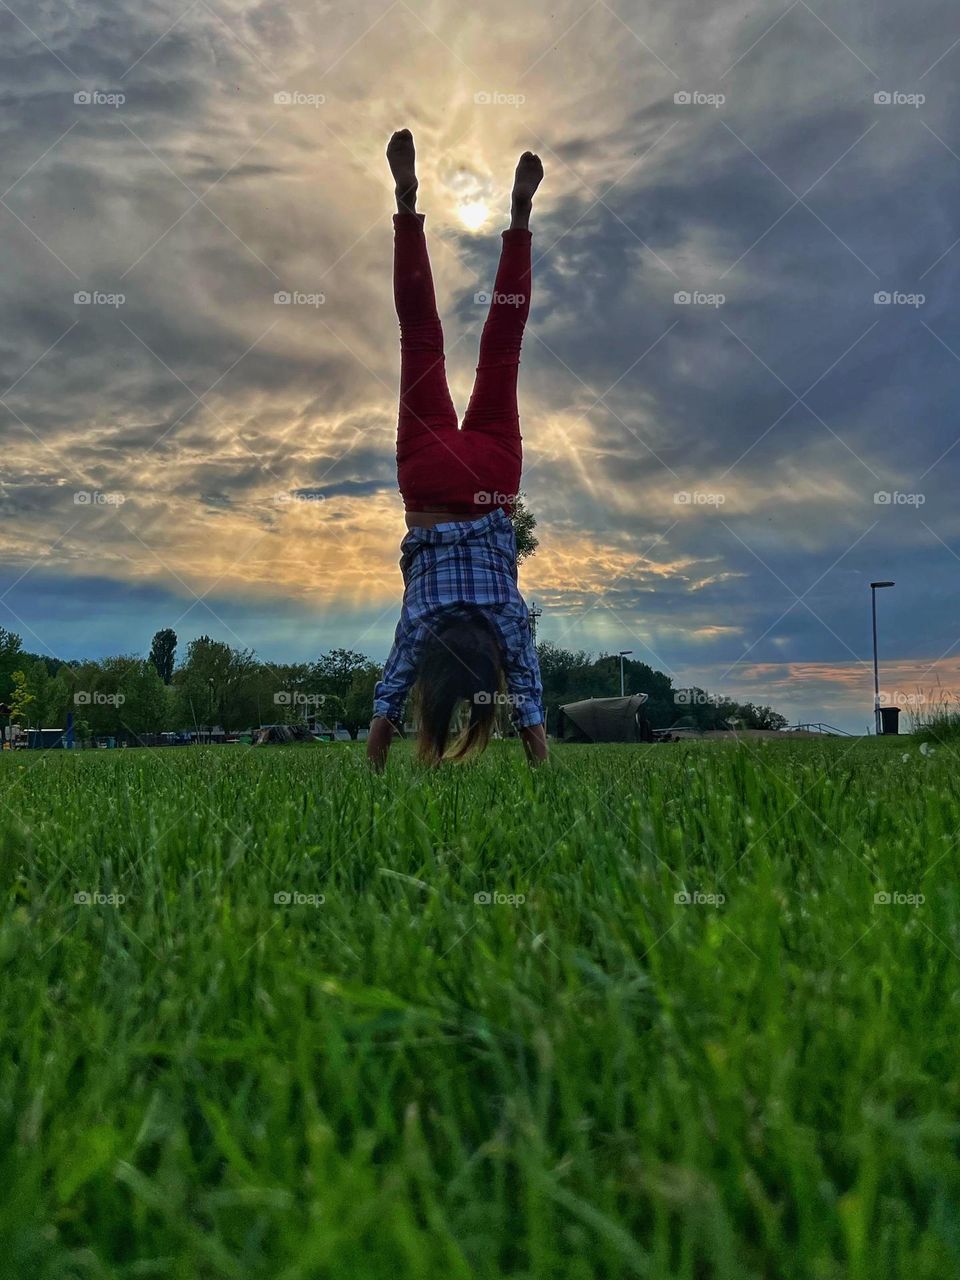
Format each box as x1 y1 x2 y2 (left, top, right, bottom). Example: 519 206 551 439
416 611 503 764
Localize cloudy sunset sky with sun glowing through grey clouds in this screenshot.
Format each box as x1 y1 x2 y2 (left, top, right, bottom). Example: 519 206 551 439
0 0 960 731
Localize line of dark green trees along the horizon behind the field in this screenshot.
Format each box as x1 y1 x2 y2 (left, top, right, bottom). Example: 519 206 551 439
0 627 787 741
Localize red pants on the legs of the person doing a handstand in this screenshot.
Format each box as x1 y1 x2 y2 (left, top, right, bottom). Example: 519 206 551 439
393 214 531 513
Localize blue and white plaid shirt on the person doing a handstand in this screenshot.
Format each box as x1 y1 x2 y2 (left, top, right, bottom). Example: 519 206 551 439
374 507 544 728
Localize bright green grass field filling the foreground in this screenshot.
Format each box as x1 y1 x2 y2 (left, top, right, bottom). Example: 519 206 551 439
0 739 960 1280
